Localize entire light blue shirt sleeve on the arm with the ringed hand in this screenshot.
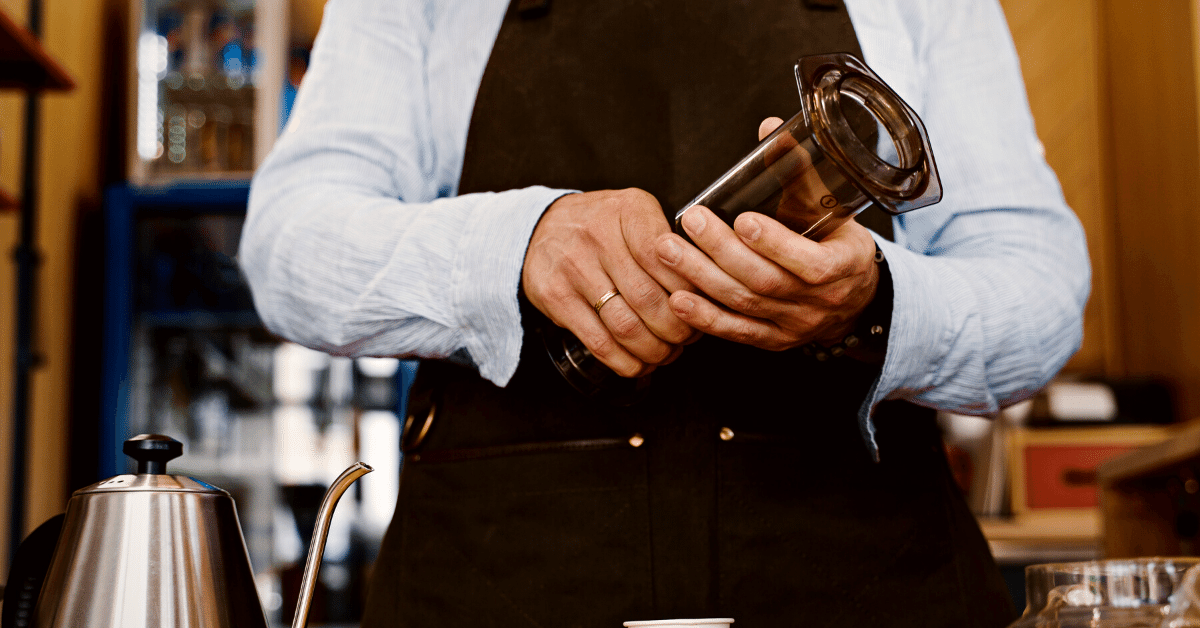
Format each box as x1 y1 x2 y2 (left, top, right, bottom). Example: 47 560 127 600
239 0 565 385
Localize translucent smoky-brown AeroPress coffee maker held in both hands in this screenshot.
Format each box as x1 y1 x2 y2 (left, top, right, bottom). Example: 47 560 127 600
541 54 942 405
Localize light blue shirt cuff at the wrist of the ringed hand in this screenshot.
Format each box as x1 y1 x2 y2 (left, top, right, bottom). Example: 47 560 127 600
450 186 574 387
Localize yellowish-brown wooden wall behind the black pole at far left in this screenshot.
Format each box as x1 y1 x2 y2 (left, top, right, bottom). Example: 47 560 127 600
0 0 110 570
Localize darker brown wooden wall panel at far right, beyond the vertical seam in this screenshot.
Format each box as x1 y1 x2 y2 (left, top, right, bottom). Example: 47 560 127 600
1099 0 1200 418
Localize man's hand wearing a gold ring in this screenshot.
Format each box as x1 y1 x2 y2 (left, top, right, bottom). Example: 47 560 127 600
521 189 700 377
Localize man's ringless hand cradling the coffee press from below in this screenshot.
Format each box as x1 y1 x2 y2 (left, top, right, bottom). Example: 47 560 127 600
658 118 880 351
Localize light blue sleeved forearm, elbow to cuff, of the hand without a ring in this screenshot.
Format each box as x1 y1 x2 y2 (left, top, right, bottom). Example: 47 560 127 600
871 207 1090 414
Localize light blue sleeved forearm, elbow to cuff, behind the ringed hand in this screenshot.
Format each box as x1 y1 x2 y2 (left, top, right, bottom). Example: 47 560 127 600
240 146 562 384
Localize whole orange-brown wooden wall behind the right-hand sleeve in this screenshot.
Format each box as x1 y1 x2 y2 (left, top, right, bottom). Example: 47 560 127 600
1001 0 1200 419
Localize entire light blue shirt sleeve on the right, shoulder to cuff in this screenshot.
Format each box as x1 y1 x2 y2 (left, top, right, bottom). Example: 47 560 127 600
856 0 1091 446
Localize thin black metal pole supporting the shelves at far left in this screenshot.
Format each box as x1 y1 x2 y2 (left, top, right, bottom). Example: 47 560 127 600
8 0 42 561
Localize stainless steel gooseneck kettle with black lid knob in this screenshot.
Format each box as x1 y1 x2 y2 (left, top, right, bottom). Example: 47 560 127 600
10 435 371 628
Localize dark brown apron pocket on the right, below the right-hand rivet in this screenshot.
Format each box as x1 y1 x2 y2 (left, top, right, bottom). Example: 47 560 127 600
718 439 960 626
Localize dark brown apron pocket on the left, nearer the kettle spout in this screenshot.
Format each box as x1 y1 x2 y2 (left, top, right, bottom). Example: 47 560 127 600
372 439 652 628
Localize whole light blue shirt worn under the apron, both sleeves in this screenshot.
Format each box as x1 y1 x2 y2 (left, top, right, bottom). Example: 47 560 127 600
240 0 1090 451
